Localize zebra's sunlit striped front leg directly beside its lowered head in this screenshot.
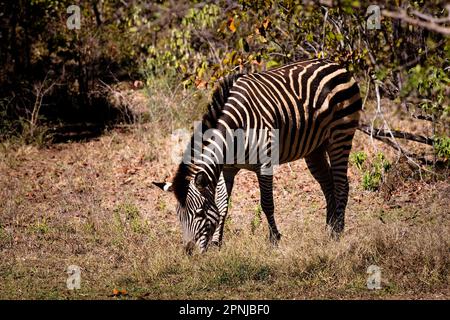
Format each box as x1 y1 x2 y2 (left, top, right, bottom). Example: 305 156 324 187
211 168 239 247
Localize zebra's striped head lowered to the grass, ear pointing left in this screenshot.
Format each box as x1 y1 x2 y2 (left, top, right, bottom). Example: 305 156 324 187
153 171 219 254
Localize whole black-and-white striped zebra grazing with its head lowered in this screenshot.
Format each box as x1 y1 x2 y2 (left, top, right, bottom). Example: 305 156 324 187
154 59 362 253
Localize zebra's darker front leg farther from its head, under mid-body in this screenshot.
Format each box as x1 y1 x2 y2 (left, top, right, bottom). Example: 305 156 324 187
257 171 281 246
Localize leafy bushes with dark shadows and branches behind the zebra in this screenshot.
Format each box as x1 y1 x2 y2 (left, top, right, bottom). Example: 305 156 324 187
0 0 450 162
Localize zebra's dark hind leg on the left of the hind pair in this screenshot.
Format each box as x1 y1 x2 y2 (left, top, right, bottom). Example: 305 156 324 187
305 146 336 232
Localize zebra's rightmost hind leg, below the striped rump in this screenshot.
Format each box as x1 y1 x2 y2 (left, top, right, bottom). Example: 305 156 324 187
327 132 354 238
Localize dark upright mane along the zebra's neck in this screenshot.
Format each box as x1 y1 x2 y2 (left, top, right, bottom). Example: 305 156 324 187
172 73 243 206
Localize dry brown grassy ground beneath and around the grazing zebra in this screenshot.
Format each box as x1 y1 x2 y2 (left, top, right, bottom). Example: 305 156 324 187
0 88 450 299
